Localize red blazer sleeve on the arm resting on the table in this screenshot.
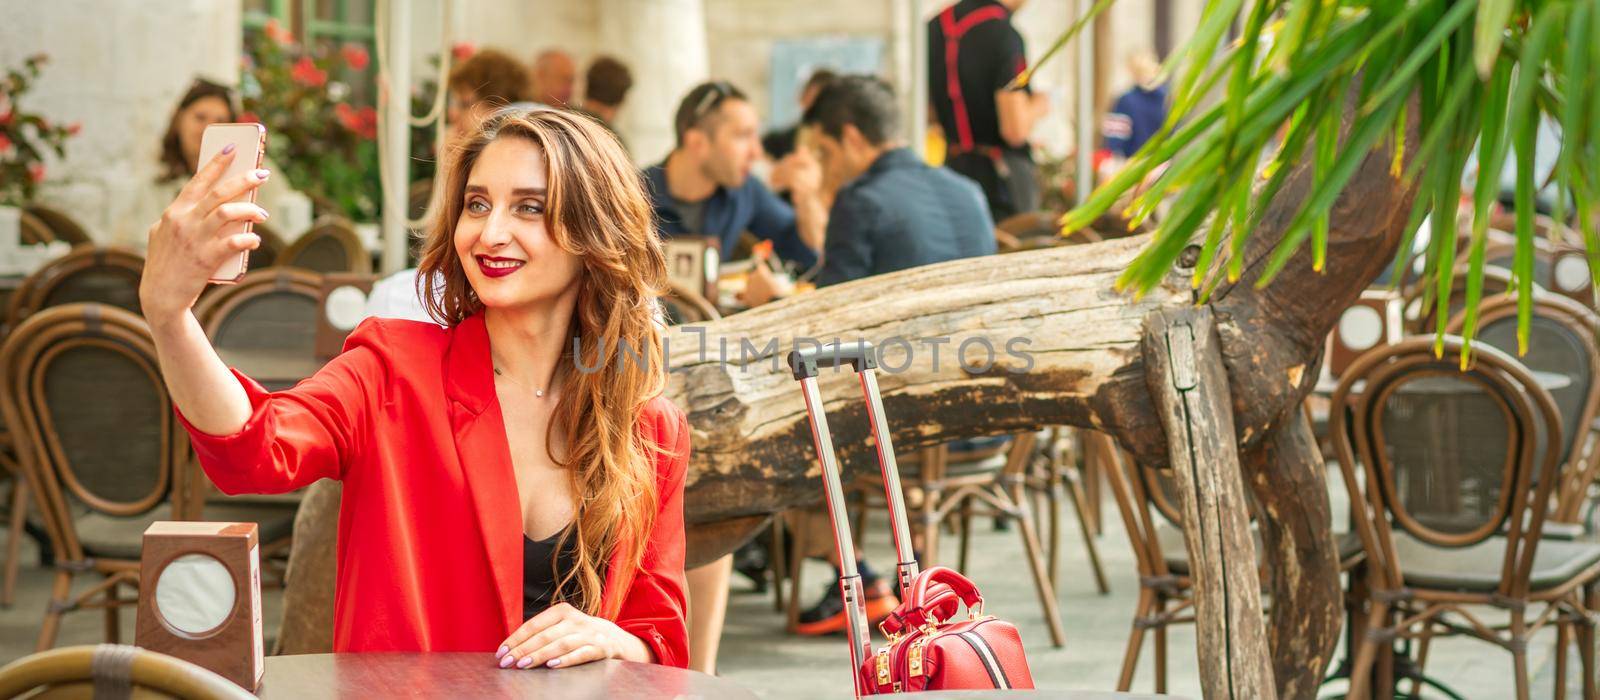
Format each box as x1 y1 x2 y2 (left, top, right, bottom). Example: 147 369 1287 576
616 409 690 668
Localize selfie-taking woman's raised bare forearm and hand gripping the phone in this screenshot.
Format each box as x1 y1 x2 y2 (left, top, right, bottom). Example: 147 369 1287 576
139 147 267 435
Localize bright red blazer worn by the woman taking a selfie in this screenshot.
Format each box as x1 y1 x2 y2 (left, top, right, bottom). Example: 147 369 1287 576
179 313 690 666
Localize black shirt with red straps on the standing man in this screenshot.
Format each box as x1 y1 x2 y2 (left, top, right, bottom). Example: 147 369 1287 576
928 0 1027 155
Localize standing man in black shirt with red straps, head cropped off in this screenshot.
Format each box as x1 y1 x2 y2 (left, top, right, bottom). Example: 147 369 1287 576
928 0 1050 222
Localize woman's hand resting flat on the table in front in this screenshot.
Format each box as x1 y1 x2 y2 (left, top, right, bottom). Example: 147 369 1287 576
494 603 654 668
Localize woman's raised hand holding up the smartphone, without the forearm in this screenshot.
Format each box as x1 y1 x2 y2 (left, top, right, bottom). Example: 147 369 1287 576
139 145 269 323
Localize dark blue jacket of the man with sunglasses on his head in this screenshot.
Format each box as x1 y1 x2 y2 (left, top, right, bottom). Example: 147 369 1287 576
645 161 816 268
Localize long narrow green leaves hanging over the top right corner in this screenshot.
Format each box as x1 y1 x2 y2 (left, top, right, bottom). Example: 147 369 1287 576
1021 0 1600 361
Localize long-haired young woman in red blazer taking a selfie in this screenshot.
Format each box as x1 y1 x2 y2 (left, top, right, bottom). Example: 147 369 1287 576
141 109 690 668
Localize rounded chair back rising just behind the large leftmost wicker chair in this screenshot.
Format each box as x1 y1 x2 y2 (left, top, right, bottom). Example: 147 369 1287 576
6 246 144 334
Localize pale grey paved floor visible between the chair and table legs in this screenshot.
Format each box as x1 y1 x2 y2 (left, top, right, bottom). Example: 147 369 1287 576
0 469 1578 698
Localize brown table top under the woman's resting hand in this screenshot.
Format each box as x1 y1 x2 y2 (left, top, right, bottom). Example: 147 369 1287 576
261 652 758 700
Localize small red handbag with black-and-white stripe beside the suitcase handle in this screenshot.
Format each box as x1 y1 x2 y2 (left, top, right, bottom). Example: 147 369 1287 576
861 566 1034 692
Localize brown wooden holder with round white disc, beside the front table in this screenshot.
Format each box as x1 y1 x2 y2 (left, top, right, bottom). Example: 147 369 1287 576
134 521 266 692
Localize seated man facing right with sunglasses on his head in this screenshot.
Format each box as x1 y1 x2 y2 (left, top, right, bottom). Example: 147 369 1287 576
645 82 827 268
